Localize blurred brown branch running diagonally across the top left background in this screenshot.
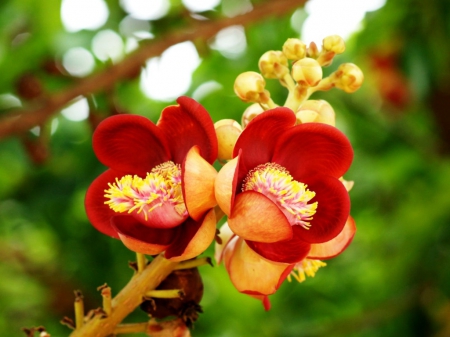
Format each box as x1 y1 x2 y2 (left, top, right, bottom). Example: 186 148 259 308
0 0 306 139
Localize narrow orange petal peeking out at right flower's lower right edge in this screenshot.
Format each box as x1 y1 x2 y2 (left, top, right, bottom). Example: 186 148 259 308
308 216 356 260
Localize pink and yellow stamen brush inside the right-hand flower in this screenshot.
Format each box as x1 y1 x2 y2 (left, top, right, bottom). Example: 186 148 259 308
242 163 318 229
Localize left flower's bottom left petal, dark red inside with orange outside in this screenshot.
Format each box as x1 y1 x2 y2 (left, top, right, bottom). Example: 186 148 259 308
111 215 177 255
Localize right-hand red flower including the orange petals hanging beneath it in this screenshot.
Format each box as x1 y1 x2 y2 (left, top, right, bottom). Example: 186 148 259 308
215 108 355 308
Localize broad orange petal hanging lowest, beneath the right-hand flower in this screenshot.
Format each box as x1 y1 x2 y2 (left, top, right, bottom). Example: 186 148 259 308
224 236 291 295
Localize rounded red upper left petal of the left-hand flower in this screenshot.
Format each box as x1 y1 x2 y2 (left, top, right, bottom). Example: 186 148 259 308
92 115 170 176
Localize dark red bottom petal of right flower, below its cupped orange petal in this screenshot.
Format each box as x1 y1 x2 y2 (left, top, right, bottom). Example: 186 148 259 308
247 226 311 263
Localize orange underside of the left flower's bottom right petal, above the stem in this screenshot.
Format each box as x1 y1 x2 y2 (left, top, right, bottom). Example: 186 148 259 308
166 209 216 262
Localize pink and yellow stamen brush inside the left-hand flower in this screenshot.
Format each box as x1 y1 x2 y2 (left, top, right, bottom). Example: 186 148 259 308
105 161 187 220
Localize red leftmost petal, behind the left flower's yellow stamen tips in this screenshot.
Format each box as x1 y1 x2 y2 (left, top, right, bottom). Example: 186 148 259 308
84 170 120 239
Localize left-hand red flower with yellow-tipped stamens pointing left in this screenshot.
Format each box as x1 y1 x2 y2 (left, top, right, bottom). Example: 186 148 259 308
85 97 217 261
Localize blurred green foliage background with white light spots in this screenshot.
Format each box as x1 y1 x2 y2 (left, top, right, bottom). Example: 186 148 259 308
0 0 450 337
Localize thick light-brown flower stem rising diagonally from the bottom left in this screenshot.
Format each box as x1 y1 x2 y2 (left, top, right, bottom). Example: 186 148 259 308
70 256 177 337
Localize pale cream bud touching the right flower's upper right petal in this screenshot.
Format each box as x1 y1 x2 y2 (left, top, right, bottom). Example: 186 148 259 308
295 100 335 126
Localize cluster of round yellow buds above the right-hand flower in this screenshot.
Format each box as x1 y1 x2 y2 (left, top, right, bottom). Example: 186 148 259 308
234 35 364 133
